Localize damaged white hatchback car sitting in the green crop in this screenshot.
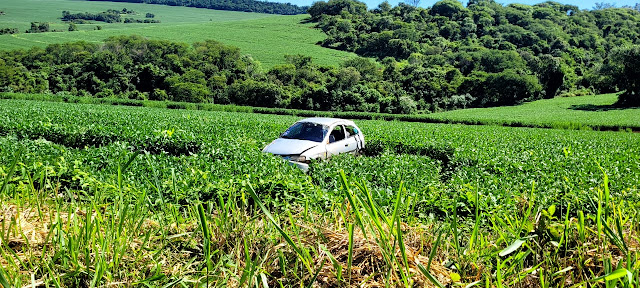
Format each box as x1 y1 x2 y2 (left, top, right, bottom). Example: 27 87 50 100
262 118 364 171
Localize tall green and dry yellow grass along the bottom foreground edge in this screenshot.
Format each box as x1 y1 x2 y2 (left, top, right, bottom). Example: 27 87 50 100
0 152 640 287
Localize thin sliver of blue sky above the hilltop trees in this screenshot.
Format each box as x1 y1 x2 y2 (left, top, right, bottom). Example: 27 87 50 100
280 0 640 9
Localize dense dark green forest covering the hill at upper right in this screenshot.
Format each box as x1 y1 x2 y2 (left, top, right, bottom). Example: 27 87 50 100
308 0 640 109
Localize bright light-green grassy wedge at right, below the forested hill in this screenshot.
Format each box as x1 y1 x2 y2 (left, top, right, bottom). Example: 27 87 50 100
430 94 640 128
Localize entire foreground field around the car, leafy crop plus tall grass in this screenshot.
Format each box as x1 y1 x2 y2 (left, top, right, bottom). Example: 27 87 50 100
0 100 640 287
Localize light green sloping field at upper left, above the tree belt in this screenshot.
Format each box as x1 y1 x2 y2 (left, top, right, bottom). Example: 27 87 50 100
0 0 354 67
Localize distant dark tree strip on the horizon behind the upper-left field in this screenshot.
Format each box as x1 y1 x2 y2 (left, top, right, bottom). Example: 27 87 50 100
88 0 309 15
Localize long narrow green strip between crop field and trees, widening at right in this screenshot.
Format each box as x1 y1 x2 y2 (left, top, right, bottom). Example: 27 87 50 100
5 92 640 131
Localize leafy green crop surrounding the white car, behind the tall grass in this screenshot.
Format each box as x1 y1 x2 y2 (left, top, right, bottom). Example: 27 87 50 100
0 100 640 215
